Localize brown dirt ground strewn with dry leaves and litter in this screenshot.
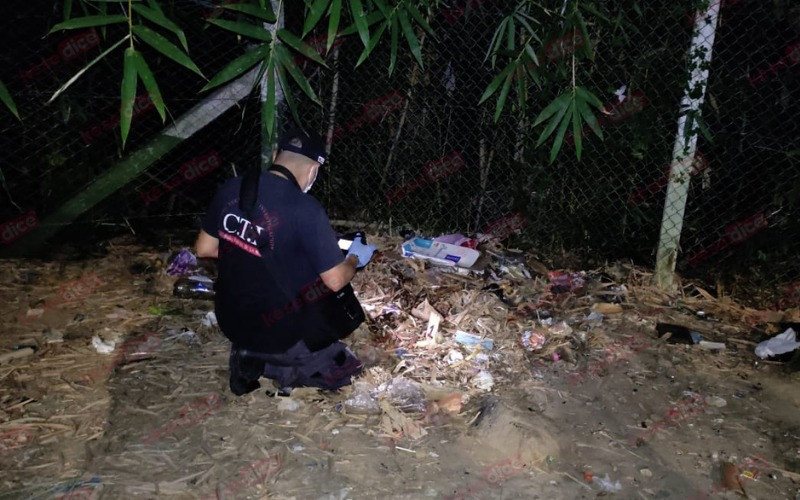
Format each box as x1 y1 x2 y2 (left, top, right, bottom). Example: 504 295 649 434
0 235 800 499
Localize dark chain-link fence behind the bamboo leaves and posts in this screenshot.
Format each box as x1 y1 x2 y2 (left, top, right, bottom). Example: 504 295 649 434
0 0 800 304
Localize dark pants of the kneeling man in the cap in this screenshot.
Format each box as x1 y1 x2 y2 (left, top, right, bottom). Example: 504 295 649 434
229 340 363 396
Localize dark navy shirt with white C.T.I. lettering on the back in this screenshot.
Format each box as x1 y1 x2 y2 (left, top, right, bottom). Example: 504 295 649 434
203 173 344 352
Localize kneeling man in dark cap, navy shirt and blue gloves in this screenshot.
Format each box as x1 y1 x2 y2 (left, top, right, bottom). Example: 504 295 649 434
196 130 375 395
